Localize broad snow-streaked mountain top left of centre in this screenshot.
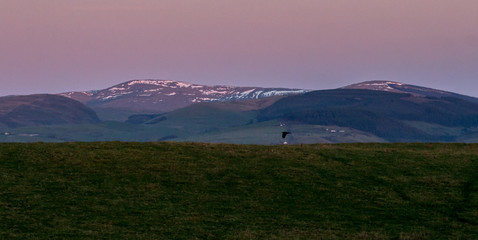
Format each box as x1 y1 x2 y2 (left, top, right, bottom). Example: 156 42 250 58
61 79 307 111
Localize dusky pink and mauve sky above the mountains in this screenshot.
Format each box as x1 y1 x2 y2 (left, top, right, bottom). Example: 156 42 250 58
0 0 478 97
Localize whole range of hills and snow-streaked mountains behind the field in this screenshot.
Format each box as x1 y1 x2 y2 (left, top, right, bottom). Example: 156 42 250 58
0 80 478 144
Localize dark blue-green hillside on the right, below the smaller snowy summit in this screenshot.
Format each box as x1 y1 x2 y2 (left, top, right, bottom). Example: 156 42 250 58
259 89 478 141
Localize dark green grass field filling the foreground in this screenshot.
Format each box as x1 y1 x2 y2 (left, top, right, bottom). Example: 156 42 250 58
0 142 478 239
